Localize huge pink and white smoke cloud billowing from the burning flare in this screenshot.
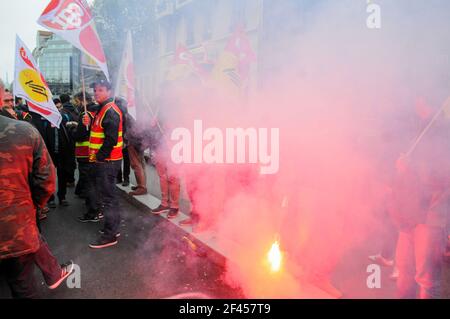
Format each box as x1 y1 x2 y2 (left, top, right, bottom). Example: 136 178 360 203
126 0 450 298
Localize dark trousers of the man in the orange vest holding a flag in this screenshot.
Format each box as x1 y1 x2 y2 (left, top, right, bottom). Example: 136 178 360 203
93 161 122 240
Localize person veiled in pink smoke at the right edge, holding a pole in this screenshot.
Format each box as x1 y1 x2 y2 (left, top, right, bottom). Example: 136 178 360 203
390 122 450 299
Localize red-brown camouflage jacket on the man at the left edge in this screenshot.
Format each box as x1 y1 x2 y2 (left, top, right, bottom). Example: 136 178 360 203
0 116 55 260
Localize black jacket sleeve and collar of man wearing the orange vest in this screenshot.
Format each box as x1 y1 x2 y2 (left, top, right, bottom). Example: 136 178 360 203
96 98 123 162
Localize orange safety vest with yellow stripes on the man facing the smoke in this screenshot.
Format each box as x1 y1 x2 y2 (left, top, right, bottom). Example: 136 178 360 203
89 102 123 161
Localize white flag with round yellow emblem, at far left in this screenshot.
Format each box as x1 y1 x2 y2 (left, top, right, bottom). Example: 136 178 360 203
14 36 62 128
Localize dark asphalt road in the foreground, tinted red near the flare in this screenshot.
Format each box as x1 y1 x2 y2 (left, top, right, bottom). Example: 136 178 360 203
0 189 242 299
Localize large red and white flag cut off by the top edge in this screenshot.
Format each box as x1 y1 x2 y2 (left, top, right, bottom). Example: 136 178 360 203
38 0 109 80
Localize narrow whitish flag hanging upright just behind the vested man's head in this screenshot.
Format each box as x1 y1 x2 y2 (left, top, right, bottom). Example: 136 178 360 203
115 32 136 120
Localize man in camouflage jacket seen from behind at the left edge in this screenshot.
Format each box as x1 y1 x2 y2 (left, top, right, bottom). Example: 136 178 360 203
0 99 73 298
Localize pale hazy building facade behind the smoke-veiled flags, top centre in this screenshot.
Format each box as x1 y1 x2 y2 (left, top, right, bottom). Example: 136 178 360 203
144 0 264 99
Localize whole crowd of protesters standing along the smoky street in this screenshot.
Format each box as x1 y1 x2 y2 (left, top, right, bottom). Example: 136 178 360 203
0 76 450 298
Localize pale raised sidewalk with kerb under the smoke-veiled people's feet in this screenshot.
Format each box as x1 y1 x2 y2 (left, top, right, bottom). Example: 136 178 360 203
117 165 332 299
